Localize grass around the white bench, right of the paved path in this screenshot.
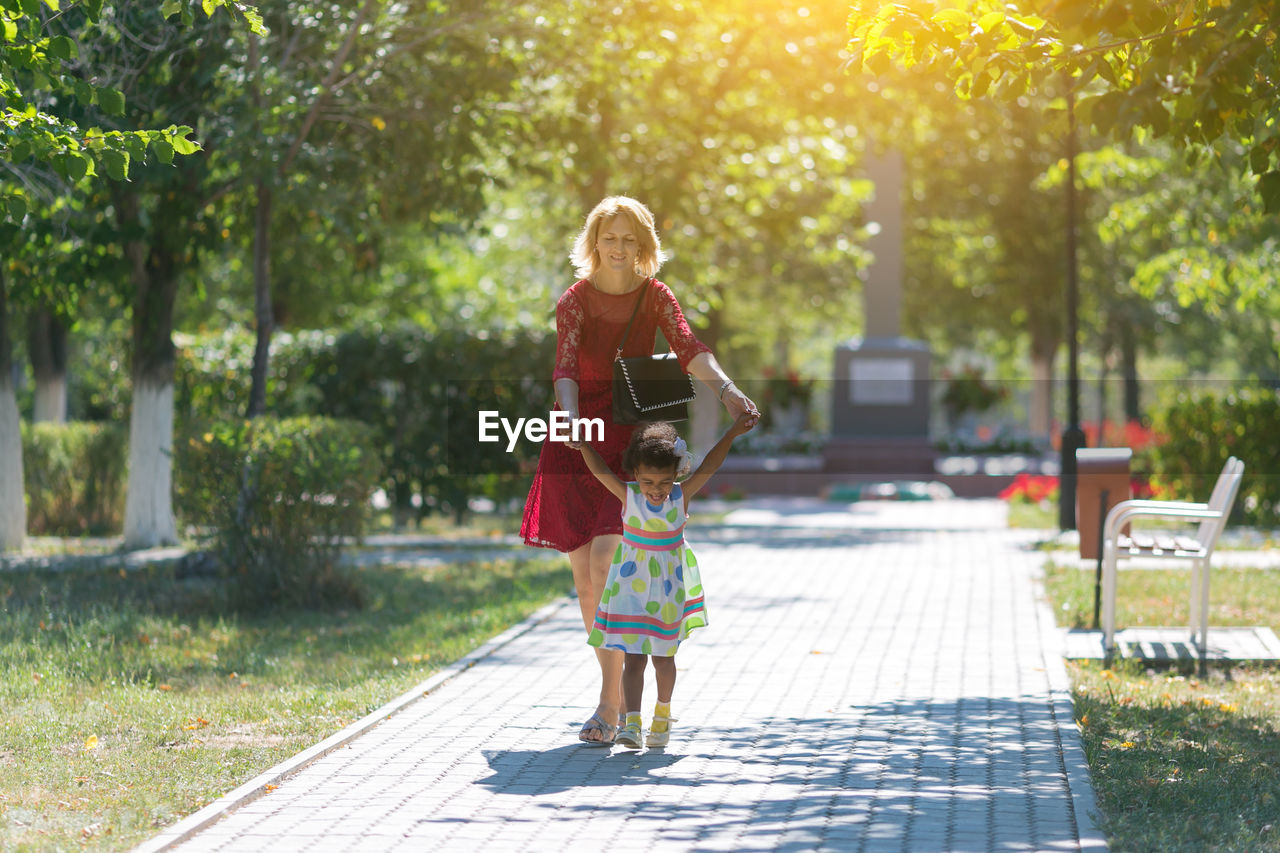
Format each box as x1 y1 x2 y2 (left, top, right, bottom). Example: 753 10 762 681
1046 566 1280 853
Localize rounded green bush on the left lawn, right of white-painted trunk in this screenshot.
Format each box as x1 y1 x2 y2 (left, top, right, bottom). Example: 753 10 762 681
175 418 381 607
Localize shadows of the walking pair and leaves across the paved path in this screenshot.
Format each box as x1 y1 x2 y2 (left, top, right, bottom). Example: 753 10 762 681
460 697 1078 850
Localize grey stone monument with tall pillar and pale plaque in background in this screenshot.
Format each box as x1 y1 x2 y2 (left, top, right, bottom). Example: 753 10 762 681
823 151 936 479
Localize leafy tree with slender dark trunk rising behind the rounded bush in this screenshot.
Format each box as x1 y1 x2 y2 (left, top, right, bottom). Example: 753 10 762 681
226 0 529 416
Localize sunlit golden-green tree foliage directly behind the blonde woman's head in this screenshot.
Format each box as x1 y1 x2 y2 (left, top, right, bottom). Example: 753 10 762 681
478 0 869 402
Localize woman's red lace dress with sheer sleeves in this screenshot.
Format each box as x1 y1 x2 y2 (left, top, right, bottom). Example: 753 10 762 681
520 279 710 551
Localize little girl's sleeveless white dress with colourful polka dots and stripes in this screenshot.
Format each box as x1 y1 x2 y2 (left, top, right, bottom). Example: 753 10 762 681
586 483 707 657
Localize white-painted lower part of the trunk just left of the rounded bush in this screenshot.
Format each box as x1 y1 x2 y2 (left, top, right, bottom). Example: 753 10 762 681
124 377 178 548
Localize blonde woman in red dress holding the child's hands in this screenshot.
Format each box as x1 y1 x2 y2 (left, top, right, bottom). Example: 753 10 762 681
520 196 759 744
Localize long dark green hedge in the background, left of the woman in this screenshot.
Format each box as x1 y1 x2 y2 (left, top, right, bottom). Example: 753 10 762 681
175 323 556 520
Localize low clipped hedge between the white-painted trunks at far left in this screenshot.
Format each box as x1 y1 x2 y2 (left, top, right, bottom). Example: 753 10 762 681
22 423 128 537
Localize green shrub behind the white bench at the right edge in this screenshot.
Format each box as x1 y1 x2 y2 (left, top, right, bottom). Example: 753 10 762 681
1147 388 1280 528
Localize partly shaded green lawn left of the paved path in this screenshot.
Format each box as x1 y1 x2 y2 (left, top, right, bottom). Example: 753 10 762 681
0 548 572 850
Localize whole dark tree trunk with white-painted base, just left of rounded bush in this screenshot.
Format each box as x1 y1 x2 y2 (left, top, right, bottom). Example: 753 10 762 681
122 193 178 548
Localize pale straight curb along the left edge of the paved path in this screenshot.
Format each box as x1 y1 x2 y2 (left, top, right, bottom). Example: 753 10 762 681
133 596 573 853
